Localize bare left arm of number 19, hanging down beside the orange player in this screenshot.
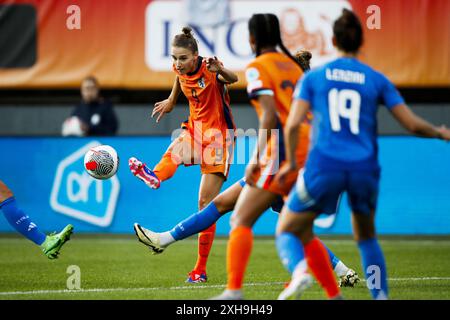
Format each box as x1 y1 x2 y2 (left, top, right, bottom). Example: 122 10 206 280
284 99 310 170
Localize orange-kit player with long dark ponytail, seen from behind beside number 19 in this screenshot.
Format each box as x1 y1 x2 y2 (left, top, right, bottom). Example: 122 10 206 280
209 14 310 300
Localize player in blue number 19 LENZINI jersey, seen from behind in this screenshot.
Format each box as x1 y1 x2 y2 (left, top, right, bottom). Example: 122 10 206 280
277 9 450 299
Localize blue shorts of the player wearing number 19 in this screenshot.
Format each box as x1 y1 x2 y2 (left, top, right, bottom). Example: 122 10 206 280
287 169 380 214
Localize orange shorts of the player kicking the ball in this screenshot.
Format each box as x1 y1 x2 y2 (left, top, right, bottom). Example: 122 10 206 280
172 123 236 179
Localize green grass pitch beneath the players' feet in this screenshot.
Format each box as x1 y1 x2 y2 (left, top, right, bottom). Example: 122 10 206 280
0 234 450 300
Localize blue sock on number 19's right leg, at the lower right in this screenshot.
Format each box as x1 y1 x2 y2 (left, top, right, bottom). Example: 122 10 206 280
358 238 388 299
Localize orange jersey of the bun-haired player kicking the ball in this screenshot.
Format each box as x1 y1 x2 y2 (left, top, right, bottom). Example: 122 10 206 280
174 56 235 145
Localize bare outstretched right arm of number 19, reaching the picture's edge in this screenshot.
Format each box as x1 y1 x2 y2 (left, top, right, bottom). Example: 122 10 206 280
391 104 450 141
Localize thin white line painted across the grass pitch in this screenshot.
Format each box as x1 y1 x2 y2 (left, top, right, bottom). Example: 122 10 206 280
0 277 450 296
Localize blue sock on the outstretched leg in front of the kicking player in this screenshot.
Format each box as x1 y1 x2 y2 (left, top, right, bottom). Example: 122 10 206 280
169 201 222 241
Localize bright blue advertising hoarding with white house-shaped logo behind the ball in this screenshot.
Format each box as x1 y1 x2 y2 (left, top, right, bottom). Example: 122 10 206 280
0 137 450 235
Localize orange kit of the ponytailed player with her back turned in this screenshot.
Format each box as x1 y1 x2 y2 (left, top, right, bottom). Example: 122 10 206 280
245 51 310 194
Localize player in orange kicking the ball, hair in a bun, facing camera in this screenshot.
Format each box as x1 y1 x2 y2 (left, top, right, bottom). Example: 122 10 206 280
129 27 238 283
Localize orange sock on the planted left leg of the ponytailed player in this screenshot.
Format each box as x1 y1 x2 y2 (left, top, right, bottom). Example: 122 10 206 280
227 226 253 290
